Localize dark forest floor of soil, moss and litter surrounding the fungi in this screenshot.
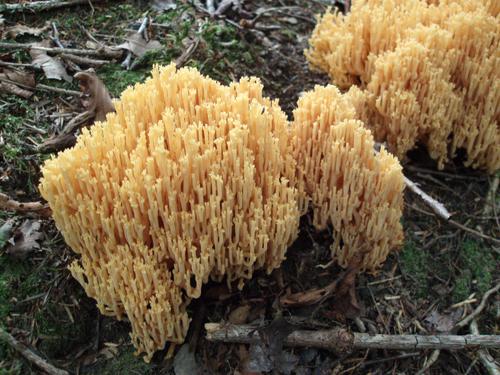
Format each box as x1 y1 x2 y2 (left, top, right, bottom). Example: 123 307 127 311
0 0 500 375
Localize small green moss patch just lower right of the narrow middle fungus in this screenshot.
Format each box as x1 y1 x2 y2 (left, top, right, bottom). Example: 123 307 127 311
400 241 429 298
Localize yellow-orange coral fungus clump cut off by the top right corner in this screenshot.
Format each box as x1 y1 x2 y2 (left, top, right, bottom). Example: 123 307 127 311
306 0 500 172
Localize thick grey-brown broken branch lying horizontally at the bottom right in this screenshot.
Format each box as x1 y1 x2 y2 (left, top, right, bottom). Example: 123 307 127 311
205 323 500 353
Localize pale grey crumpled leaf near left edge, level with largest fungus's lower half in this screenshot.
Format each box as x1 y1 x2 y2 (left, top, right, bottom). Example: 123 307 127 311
6 220 43 259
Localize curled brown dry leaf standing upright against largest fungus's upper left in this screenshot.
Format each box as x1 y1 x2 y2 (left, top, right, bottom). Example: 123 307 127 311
75 69 115 121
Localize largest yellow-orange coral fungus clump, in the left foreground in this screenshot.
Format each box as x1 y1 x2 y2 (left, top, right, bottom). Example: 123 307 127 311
40 65 299 360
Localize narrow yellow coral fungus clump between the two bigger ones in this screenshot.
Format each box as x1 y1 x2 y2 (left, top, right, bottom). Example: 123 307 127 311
291 85 404 271
